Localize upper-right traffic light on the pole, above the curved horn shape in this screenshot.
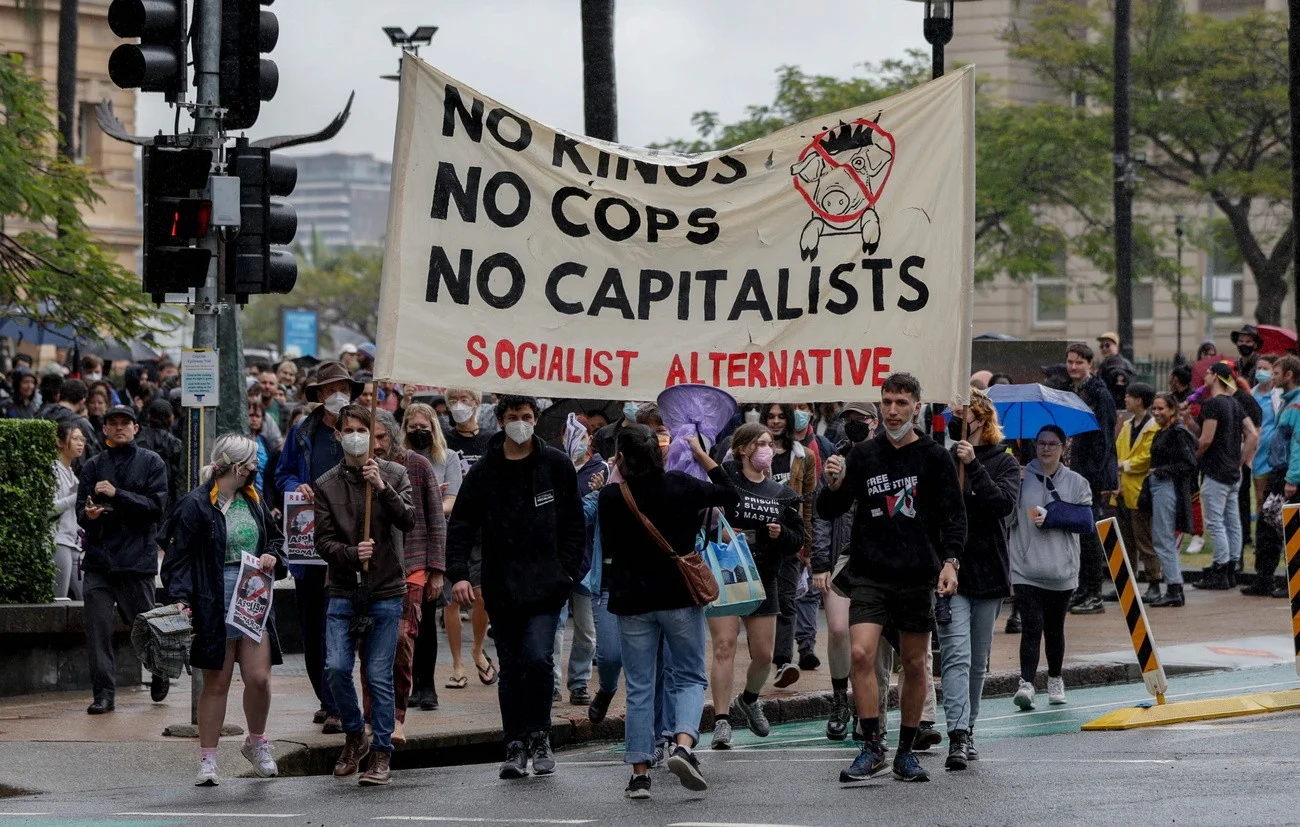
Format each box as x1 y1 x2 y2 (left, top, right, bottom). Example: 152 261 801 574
221 0 280 129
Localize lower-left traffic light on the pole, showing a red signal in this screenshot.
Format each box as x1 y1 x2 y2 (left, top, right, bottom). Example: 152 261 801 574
140 146 212 303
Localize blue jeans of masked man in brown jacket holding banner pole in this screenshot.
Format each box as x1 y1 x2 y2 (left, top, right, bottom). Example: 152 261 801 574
325 597 406 753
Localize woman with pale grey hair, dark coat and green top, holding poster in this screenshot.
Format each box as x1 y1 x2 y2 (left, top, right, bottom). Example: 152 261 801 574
163 434 289 787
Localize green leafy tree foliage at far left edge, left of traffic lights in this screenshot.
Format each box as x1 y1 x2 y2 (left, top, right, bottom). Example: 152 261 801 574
0 55 163 338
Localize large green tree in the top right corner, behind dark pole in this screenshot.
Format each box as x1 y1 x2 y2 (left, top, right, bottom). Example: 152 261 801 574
1008 0 1295 324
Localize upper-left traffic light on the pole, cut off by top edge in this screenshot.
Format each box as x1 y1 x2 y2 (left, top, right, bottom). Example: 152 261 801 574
108 0 186 103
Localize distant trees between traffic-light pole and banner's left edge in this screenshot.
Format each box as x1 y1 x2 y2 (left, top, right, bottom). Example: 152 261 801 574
242 233 384 345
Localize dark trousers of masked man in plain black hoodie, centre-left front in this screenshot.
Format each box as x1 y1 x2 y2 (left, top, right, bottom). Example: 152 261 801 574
491 609 560 744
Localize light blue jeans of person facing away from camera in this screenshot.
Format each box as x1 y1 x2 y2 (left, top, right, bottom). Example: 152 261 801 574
619 606 709 763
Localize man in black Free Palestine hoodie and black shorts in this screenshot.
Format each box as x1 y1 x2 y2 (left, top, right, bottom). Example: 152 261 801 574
816 373 966 784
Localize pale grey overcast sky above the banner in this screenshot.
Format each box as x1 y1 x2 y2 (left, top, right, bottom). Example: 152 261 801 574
137 0 928 160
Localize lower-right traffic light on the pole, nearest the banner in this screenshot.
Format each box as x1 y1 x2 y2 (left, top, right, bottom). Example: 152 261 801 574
225 138 298 303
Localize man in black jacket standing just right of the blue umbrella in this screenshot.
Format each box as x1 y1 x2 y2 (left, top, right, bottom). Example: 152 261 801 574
1065 342 1119 615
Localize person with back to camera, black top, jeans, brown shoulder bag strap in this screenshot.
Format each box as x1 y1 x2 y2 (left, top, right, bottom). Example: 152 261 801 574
598 425 740 798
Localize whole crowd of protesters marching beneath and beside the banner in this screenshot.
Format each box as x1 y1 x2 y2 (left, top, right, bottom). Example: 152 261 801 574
0 326 1300 798
